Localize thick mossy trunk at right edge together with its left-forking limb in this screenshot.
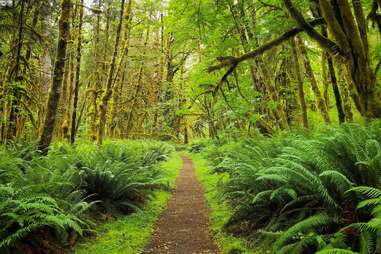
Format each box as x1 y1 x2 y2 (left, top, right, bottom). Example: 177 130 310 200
283 0 381 118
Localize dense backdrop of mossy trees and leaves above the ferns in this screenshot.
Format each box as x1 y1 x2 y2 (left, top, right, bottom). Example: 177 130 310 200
0 0 381 148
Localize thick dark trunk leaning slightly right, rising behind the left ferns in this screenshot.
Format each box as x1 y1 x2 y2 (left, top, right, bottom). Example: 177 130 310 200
38 0 72 154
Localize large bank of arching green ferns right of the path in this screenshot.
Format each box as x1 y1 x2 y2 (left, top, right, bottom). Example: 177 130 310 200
206 122 381 254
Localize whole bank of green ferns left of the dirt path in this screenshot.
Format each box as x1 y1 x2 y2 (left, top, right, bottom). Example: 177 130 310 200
0 141 173 253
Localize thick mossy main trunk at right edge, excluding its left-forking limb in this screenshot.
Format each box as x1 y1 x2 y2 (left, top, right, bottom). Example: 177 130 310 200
319 0 381 118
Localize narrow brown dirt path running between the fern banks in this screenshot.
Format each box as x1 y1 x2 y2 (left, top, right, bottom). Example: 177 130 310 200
144 157 219 254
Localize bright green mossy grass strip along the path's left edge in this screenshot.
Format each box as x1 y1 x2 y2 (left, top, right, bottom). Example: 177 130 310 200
74 154 182 254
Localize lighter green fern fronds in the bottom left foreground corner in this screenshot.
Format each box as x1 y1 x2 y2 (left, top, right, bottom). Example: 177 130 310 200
0 186 89 250
